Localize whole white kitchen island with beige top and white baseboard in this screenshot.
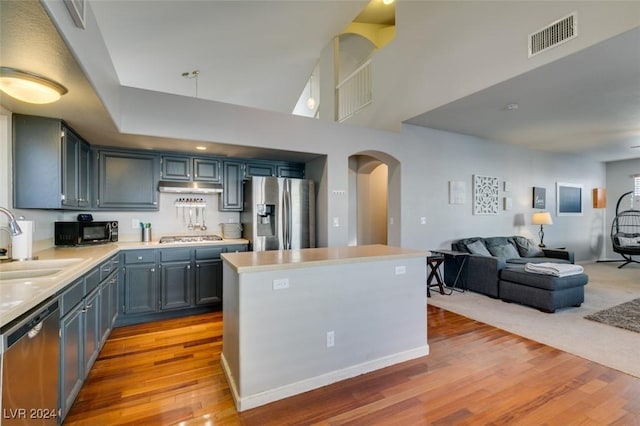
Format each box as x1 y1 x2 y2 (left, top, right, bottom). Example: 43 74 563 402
222 245 429 411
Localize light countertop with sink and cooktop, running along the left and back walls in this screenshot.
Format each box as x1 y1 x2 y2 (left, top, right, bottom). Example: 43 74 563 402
0 239 248 327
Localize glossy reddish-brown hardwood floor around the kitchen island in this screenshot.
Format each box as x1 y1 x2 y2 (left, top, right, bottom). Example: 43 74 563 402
65 306 640 426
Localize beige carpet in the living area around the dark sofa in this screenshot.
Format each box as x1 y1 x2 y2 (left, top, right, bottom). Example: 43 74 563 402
427 263 640 377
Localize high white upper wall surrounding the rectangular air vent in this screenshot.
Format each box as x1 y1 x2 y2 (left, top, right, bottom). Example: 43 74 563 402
349 1 640 129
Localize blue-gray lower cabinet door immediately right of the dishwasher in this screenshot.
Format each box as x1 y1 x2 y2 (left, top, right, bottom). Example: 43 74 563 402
60 303 85 418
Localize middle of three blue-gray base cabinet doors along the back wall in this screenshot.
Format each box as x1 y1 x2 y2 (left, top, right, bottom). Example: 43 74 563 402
160 261 193 311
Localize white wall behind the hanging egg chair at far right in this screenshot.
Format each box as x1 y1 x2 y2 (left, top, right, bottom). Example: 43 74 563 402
605 158 640 259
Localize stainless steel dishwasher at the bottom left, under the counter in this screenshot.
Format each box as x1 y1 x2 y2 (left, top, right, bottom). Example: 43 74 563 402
0 299 60 426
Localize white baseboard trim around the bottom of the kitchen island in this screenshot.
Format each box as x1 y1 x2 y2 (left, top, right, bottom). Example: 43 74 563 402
220 344 429 411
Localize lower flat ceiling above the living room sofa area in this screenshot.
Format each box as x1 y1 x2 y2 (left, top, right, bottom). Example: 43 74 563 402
406 28 640 161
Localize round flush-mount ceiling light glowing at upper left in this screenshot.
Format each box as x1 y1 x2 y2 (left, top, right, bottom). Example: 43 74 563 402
0 67 67 104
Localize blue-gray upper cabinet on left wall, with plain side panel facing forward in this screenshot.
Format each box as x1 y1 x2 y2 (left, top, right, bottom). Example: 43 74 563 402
13 114 91 210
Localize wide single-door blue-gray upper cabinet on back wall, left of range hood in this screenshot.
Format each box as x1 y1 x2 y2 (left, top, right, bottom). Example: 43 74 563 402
96 150 160 210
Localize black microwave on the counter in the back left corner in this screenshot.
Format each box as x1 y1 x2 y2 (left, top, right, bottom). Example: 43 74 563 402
54 220 118 246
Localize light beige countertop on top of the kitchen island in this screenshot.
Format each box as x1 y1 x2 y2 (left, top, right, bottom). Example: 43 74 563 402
222 244 428 273
